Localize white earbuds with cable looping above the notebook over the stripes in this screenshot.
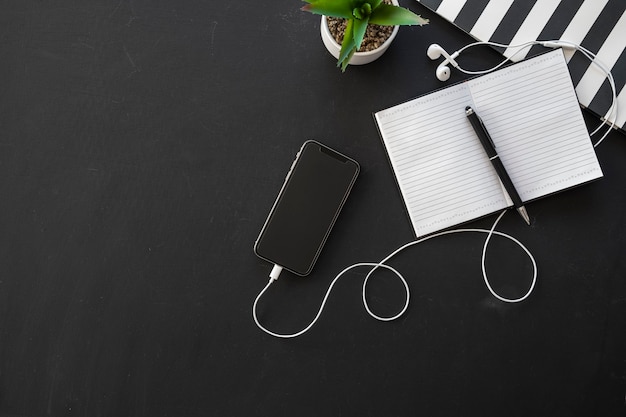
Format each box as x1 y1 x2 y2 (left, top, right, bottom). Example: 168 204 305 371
426 39 617 146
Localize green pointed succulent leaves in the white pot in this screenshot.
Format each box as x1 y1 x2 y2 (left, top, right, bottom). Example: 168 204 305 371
302 0 428 71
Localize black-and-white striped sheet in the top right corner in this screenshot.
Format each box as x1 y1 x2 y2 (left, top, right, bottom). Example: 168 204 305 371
417 0 626 130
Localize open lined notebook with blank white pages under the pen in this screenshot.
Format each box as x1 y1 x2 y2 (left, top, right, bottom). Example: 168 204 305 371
374 50 602 237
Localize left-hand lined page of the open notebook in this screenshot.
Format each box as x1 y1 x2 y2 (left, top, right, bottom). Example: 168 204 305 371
374 84 508 236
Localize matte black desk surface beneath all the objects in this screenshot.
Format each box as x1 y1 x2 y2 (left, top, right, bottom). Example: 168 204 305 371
0 0 626 416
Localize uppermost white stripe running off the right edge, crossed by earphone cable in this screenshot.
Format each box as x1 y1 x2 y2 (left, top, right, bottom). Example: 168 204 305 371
576 13 626 111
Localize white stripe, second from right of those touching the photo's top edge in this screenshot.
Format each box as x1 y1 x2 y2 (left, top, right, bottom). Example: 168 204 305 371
504 0 561 61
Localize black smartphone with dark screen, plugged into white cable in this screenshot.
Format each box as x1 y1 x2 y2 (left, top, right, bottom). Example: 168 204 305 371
254 140 360 276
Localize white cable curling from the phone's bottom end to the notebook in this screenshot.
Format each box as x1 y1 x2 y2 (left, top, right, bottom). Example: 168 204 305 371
252 210 537 339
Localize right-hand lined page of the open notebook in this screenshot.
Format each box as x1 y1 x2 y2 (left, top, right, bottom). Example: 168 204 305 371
468 50 602 201
